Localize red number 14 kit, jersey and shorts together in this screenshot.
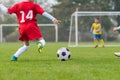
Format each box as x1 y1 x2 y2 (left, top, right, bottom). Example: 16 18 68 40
8 2 45 41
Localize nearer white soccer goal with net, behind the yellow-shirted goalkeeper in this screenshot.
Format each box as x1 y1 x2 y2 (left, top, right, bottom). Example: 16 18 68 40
68 10 120 47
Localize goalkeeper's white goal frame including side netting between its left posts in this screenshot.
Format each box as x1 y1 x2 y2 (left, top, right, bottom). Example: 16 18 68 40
68 10 120 47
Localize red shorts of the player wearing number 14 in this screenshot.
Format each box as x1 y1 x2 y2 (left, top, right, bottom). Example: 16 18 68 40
19 22 42 41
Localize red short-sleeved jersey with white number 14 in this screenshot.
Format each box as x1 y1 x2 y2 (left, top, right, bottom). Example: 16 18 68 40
8 2 45 24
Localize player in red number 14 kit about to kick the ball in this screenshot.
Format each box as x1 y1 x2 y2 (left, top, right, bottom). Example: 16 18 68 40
0 0 61 61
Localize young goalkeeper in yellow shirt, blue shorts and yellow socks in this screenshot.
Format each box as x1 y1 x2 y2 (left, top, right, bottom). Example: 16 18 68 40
91 18 105 48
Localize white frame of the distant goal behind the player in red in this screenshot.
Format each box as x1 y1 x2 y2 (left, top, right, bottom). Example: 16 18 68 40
0 24 58 43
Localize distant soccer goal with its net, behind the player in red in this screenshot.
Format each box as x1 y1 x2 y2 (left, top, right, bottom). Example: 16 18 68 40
0 24 58 43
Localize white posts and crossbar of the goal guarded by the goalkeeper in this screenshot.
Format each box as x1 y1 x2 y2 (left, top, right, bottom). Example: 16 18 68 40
68 10 120 47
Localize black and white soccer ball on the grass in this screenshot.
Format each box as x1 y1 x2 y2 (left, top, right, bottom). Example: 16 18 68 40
57 48 71 61
